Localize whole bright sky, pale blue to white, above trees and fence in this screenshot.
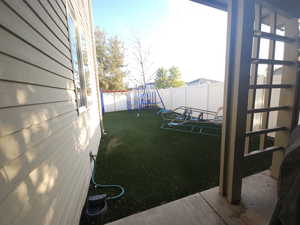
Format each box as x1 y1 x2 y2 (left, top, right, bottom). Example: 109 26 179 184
93 0 227 84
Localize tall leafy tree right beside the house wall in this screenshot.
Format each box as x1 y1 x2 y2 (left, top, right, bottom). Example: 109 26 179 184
95 27 126 90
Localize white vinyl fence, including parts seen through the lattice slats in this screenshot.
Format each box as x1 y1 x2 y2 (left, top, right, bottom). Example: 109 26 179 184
103 76 292 136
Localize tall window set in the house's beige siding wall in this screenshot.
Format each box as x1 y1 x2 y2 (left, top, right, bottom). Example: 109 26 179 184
68 12 86 112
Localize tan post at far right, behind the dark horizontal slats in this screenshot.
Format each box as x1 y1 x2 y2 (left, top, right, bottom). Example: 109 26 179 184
271 17 299 178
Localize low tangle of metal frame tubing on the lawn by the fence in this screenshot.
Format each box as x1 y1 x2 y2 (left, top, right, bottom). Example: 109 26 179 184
159 106 223 136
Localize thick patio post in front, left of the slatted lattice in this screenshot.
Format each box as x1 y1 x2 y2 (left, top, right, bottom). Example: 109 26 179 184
220 0 254 203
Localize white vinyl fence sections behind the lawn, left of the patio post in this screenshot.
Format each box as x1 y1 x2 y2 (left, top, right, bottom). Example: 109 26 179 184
103 83 224 112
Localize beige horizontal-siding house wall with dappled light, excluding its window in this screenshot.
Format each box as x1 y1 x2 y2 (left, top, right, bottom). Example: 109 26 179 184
0 0 101 225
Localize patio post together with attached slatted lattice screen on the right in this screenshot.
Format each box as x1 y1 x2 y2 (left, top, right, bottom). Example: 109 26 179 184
220 0 299 203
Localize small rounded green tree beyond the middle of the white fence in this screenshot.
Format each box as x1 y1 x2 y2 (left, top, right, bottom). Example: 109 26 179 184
155 66 184 88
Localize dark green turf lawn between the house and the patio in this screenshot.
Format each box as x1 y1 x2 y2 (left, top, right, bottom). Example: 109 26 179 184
90 110 270 222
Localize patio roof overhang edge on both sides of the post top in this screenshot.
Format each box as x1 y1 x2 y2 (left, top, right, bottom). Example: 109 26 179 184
191 0 300 18
